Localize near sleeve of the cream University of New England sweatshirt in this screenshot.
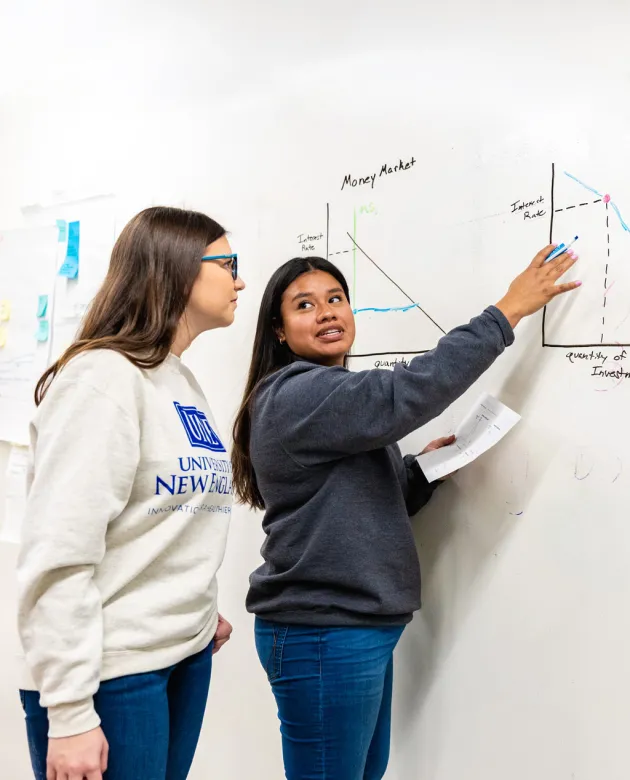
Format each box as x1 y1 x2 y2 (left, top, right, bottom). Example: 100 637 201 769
18 375 140 737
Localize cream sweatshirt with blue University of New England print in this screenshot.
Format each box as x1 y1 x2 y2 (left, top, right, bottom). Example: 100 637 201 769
18 350 232 737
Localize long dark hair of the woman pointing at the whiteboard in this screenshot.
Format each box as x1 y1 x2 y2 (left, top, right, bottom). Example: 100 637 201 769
232 257 350 509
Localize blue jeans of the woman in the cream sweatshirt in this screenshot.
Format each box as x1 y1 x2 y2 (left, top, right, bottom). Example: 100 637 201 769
20 643 212 780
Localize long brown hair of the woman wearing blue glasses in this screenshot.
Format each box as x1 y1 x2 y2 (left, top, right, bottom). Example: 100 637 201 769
35 206 225 405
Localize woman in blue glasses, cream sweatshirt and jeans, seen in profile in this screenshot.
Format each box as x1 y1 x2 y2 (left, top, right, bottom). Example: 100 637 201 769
18 208 245 780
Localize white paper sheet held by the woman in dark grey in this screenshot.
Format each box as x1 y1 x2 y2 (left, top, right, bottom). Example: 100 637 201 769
418 393 521 482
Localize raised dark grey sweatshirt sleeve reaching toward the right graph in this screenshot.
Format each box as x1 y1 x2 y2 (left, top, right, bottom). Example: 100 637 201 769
272 306 514 466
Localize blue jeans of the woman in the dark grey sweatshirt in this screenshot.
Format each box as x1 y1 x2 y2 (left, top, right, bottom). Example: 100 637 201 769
256 618 403 780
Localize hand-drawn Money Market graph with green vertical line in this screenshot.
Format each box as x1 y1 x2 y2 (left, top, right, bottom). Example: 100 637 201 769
326 204 446 358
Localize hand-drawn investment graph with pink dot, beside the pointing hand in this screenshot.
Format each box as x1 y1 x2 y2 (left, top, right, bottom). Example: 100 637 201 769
542 165 630 349
